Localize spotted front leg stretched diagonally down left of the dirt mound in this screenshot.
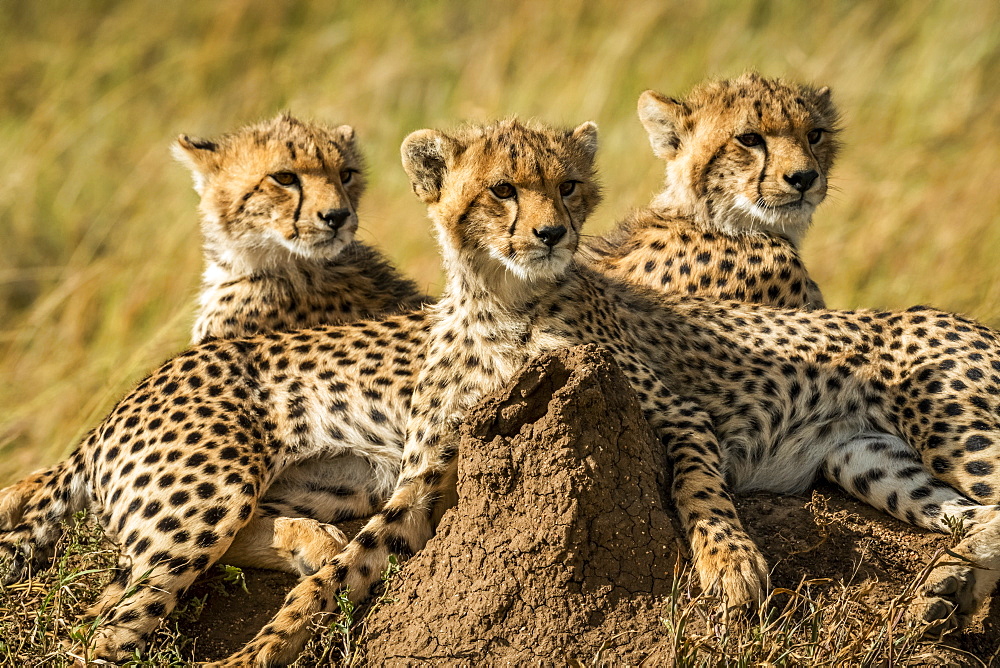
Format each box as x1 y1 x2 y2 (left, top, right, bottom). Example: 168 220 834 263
212 424 458 667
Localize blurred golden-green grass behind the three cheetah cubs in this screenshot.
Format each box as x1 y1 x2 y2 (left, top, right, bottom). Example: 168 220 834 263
0 0 1000 483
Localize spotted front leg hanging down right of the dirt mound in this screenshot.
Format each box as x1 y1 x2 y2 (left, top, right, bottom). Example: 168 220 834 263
643 388 770 608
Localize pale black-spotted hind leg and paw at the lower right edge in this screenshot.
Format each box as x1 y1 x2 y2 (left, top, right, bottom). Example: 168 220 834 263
823 432 1000 635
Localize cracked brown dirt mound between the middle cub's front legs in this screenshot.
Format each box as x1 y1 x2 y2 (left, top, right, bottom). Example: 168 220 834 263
366 346 678 665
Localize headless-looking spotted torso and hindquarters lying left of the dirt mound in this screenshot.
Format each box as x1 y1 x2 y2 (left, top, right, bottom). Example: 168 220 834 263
0 310 429 661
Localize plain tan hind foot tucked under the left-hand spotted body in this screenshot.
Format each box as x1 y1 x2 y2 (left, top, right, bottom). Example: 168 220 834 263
219 515 348 575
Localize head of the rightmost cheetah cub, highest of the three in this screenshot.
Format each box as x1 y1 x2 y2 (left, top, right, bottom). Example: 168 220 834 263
639 73 838 243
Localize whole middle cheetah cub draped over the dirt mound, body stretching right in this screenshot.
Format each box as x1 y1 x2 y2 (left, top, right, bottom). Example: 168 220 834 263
223 121 1000 665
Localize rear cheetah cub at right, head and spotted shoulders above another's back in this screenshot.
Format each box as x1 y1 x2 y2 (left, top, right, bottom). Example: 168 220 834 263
589 73 839 309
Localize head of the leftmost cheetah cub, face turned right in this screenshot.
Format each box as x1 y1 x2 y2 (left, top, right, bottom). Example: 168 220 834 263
173 114 364 271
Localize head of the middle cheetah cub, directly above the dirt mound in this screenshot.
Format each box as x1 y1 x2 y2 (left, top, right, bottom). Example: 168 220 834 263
401 119 600 282
